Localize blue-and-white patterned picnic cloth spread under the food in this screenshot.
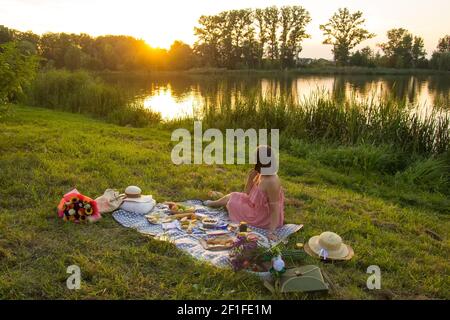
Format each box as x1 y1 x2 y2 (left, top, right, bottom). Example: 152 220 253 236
113 200 303 267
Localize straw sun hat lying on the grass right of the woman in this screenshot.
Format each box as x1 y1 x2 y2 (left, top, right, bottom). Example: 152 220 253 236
304 231 354 260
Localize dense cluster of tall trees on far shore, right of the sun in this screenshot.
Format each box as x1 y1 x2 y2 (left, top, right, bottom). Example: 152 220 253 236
194 6 311 68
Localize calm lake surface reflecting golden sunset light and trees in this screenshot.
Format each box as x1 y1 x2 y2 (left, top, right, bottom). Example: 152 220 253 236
104 74 450 120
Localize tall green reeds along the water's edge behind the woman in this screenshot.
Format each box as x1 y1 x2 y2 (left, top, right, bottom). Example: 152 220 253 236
202 91 450 155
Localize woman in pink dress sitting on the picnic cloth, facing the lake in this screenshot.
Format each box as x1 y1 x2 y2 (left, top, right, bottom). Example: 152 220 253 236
205 146 284 240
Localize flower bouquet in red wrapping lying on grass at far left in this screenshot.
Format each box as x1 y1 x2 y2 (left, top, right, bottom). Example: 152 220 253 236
58 189 101 223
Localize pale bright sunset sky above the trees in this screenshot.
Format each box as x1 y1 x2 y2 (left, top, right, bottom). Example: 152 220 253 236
0 0 450 58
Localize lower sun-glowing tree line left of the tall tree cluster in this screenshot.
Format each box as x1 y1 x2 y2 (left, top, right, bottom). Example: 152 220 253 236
0 26 194 71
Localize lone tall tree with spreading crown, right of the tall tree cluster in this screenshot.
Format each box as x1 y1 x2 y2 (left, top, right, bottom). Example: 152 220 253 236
320 8 375 65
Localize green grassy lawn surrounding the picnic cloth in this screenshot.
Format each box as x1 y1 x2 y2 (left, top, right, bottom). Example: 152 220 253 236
0 106 450 299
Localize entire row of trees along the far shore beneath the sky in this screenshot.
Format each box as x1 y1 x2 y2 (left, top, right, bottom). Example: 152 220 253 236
0 6 450 71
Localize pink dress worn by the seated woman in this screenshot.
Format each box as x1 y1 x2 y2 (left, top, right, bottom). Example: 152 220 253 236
227 184 284 229
